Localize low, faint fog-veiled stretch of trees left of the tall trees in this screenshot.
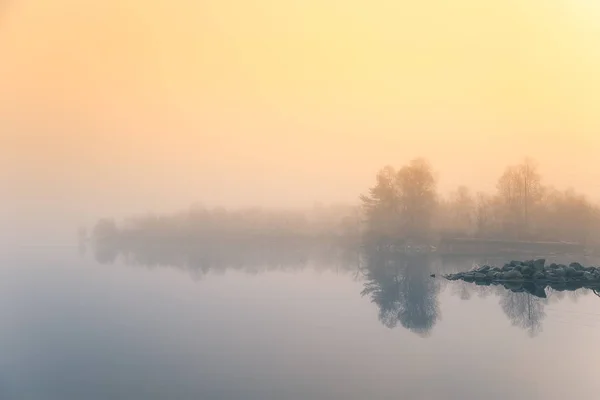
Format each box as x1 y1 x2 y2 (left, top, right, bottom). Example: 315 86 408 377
91 205 360 264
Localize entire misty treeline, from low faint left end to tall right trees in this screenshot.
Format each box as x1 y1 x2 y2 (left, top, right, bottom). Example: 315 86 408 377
91 159 600 256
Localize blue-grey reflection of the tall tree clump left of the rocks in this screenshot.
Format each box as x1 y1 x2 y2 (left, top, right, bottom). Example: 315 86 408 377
362 249 440 336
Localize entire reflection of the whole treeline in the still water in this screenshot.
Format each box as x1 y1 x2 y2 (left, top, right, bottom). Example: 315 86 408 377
94 238 590 337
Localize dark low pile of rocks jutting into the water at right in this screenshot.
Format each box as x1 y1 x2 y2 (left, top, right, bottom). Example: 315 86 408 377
444 259 600 297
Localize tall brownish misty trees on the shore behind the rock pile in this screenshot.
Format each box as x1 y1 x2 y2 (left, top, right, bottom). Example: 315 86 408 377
361 158 600 245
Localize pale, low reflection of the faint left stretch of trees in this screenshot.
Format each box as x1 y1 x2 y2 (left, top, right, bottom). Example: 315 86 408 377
94 236 359 278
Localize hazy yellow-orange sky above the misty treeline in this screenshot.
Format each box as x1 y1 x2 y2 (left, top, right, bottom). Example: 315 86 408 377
0 0 600 241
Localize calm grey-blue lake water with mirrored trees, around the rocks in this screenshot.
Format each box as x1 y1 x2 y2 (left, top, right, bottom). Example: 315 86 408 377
0 247 600 400
